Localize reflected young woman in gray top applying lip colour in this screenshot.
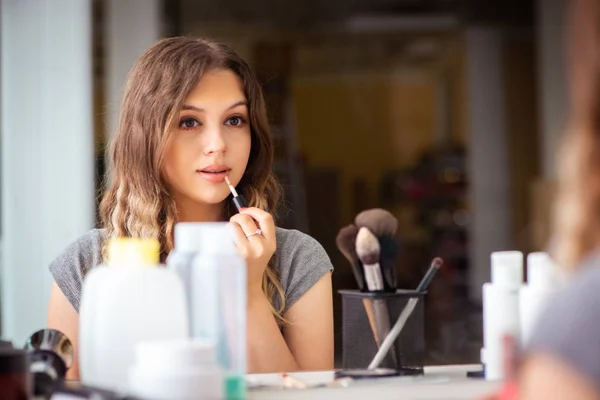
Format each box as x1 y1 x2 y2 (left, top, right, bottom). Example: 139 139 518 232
48 37 333 378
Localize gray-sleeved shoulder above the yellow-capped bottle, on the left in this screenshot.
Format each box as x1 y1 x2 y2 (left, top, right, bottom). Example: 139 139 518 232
49 229 105 310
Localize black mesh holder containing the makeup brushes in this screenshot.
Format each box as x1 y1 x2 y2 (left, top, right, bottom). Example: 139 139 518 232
339 290 426 375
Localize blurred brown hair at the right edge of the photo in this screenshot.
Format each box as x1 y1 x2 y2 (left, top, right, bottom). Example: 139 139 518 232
553 0 600 268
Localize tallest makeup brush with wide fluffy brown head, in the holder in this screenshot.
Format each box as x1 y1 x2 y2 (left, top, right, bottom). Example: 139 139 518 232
354 208 399 292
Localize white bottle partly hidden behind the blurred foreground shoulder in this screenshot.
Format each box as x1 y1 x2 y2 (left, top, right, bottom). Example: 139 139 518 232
519 252 557 347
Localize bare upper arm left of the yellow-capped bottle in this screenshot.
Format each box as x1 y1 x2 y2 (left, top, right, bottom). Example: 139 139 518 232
46 281 79 379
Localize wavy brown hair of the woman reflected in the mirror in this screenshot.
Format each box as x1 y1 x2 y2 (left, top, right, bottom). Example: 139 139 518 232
100 37 285 317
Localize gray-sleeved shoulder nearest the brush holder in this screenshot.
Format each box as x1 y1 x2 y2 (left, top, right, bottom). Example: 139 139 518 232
276 228 333 309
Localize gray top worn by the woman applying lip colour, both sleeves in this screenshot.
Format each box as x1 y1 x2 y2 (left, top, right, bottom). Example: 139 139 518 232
50 228 333 313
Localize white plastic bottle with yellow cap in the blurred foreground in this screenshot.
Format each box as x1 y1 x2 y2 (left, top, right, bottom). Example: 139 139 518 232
80 238 189 390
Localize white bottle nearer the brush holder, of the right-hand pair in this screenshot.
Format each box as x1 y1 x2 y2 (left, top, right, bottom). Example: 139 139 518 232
482 251 523 380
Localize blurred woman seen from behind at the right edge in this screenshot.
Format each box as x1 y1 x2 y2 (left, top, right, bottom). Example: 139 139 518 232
506 0 600 400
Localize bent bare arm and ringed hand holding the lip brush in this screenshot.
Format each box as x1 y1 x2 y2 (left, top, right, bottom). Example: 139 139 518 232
231 208 333 373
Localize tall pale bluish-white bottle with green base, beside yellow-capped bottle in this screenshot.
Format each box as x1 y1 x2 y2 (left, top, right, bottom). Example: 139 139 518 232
190 223 248 400
